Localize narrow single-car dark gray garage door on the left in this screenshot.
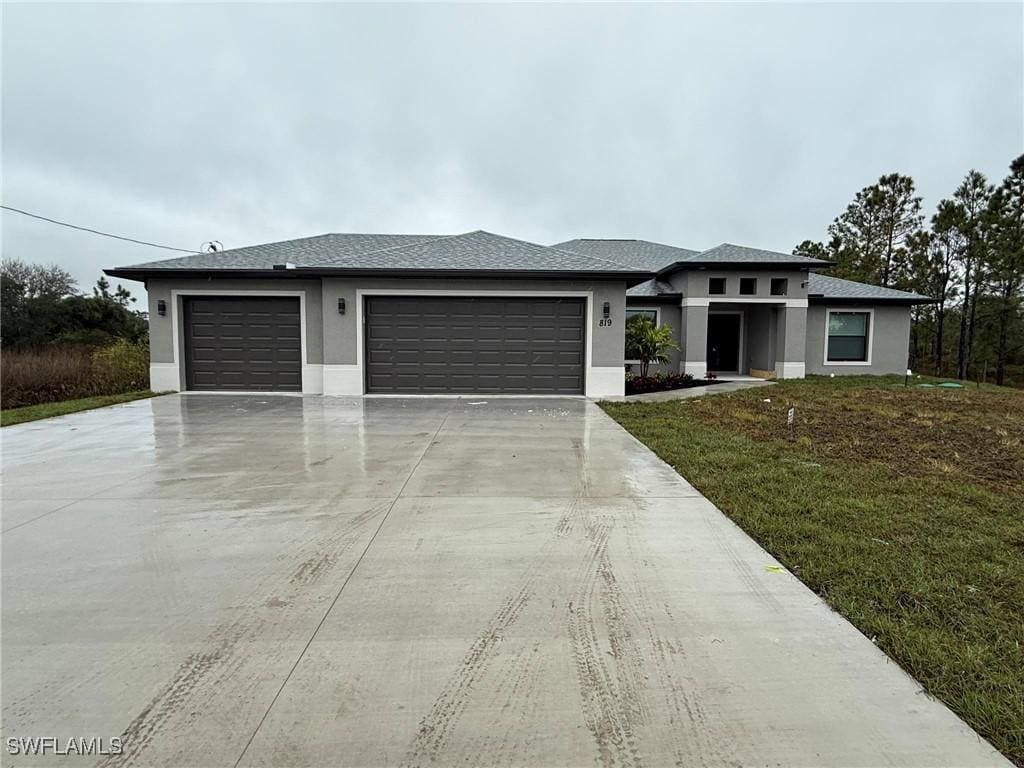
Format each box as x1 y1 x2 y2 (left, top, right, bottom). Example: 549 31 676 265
184 296 302 392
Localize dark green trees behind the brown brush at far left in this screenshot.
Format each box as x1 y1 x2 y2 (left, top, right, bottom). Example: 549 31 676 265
0 259 148 349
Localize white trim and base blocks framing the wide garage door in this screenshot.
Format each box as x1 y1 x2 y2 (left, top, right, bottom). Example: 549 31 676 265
335 288 598 397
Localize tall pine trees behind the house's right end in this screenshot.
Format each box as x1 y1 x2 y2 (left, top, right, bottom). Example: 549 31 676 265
793 155 1024 384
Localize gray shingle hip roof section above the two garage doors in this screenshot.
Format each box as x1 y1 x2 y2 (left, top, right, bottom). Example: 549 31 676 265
108 230 651 278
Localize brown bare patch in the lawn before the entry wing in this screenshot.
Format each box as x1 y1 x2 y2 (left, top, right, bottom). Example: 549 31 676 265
684 377 1024 494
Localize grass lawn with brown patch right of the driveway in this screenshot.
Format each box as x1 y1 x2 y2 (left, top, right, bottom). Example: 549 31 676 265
602 377 1024 765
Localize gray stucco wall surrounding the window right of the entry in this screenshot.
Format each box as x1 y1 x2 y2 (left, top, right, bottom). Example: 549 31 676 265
806 304 910 376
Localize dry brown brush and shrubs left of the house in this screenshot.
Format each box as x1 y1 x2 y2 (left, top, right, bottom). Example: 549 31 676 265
0 340 150 409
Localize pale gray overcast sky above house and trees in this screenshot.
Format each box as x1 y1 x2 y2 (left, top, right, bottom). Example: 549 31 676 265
2 2 1024 296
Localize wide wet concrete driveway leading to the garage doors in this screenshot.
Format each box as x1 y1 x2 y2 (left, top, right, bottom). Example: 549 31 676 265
2 395 1009 766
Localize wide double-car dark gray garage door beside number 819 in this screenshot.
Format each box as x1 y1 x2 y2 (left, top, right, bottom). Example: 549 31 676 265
365 296 586 394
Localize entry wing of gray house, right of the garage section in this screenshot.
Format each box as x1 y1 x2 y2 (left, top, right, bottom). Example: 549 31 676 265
555 240 931 379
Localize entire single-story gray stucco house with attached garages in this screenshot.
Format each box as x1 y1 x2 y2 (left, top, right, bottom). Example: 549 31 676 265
105 231 929 397
